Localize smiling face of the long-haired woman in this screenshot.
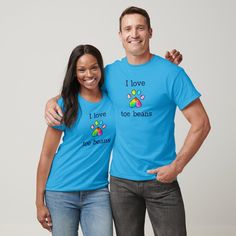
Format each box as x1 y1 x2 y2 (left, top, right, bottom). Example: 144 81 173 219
76 54 101 90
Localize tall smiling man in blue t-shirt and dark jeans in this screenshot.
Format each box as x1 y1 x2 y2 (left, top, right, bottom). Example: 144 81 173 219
46 7 210 236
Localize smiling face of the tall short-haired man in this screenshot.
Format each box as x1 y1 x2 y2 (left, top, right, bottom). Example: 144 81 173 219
119 14 152 56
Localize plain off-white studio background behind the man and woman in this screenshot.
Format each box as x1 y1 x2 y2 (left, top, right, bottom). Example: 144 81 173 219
0 0 236 236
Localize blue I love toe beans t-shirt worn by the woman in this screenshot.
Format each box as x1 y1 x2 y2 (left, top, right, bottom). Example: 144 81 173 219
46 93 115 191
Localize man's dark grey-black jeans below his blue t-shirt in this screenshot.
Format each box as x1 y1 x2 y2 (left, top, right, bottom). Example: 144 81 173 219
110 176 187 236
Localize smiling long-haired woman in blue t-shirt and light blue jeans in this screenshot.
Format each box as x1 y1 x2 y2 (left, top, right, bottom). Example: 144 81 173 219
36 45 115 236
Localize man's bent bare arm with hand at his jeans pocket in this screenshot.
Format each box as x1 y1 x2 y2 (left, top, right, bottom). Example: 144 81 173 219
148 99 211 183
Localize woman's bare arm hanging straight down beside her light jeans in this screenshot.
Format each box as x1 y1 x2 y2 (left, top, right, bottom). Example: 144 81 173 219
36 127 62 231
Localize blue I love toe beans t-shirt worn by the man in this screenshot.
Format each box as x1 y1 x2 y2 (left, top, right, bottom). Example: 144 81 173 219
105 55 200 180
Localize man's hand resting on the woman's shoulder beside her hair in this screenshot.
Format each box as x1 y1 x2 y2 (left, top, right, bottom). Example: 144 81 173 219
45 97 63 126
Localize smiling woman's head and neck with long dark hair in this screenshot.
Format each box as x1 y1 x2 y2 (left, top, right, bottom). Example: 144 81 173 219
61 45 104 127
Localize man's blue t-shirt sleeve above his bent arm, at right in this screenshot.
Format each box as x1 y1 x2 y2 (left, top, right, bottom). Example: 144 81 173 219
172 69 201 110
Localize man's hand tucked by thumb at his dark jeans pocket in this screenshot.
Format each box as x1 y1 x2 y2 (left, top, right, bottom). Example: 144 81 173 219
147 162 180 183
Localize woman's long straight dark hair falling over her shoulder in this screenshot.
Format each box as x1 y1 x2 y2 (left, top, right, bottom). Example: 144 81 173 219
61 44 104 127
